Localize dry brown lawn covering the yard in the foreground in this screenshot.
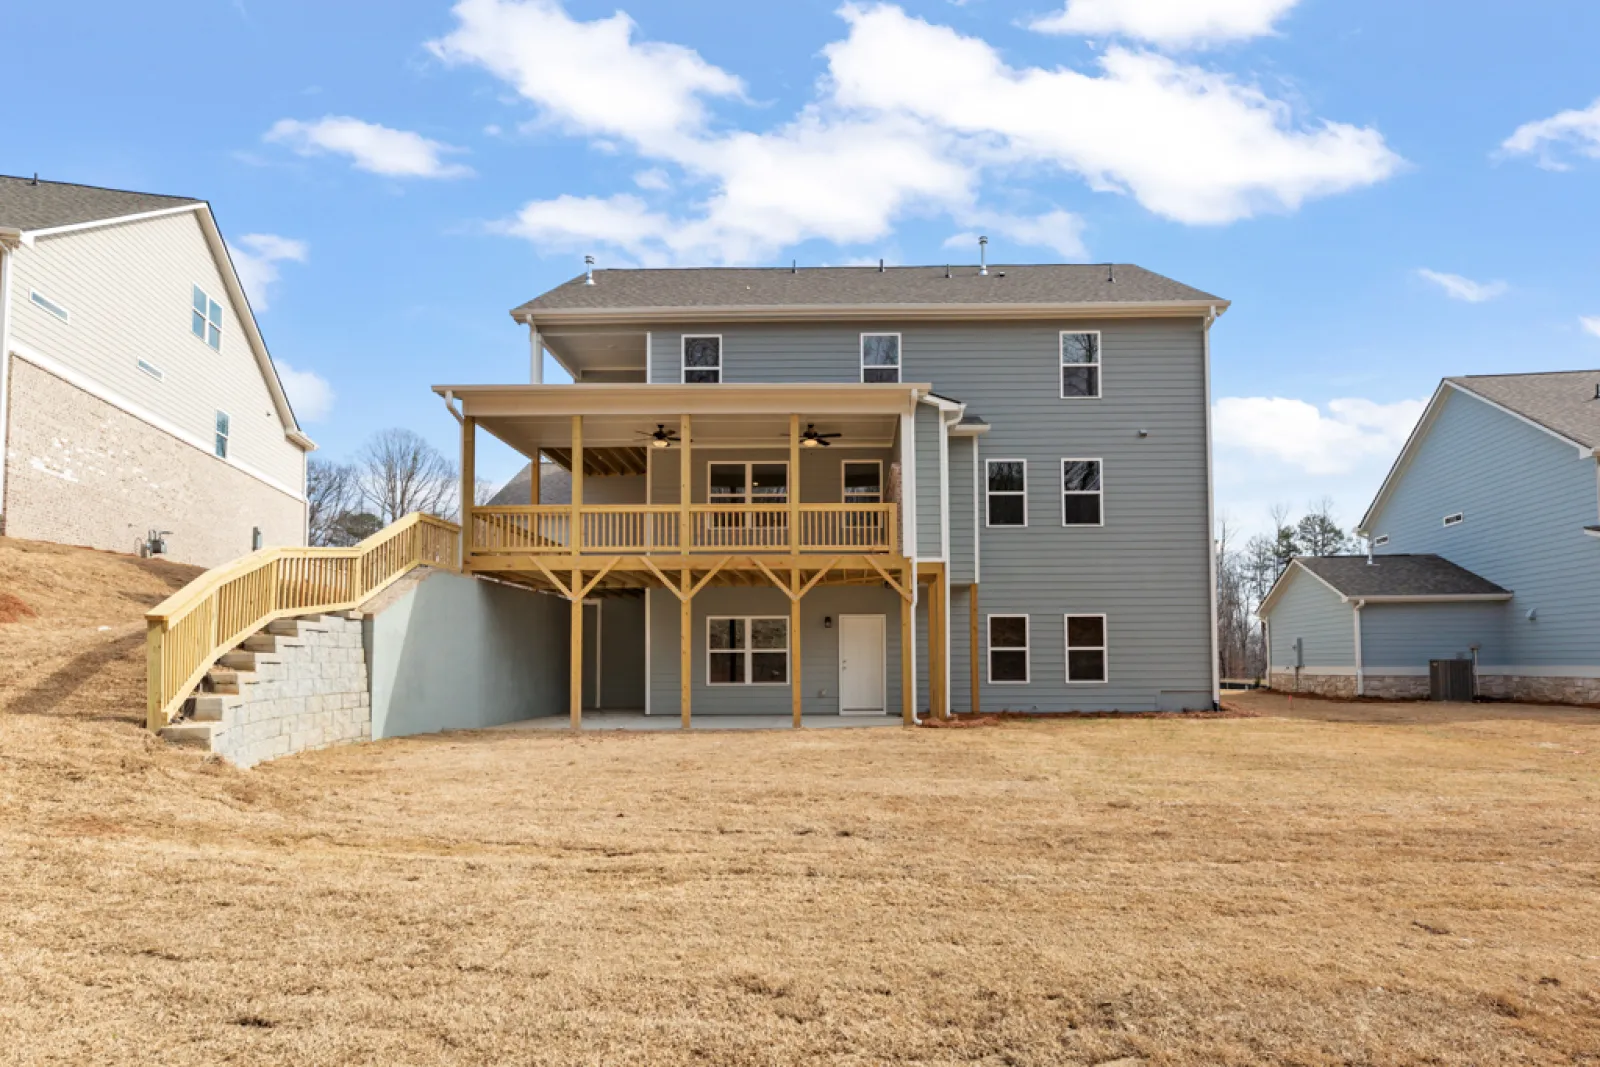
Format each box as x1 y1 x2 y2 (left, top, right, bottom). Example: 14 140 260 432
0 541 1600 1067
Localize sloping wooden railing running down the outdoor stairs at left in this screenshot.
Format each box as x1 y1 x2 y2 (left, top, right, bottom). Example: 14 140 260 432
144 514 461 729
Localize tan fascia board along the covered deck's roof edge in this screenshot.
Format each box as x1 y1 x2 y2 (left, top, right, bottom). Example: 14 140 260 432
434 382 930 418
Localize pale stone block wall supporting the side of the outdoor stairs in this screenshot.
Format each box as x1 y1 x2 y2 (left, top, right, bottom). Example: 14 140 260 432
211 616 373 766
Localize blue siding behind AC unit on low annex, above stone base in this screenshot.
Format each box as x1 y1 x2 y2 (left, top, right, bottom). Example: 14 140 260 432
1362 603 1509 675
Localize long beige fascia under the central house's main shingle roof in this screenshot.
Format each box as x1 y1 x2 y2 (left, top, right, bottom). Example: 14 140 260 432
512 301 1229 328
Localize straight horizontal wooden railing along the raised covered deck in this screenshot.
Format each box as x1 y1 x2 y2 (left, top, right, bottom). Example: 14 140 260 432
467 504 898 555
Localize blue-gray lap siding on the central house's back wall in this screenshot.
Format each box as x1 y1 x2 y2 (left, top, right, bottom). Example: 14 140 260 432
630 318 1211 710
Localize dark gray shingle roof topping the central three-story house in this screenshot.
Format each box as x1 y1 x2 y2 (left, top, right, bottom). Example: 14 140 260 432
512 264 1226 314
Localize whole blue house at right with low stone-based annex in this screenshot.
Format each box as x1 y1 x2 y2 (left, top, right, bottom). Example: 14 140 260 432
1261 371 1600 704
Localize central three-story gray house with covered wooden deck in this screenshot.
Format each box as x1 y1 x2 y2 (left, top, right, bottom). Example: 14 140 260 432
435 264 1227 725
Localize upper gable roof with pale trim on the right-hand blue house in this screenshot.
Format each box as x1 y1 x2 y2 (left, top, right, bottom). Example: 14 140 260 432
1355 371 1600 534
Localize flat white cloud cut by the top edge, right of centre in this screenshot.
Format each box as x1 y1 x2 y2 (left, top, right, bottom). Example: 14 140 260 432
1029 0 1299 46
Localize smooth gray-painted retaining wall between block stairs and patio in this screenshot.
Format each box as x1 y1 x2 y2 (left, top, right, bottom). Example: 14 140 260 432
365 571 571 737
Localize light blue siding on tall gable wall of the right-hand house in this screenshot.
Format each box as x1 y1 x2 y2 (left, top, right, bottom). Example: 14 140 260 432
1371 383 1600 667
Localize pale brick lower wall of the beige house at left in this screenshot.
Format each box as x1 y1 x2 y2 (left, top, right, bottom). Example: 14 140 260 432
0 358 306 566
